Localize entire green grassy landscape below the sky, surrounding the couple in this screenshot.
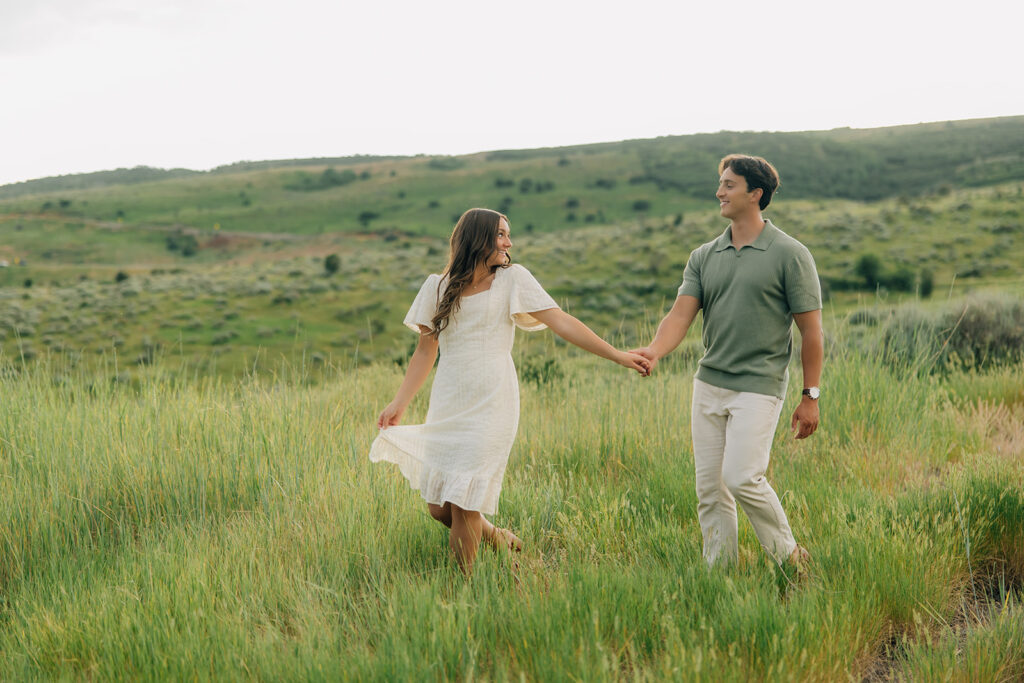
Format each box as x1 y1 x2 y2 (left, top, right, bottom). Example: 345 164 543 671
0 117 1024 681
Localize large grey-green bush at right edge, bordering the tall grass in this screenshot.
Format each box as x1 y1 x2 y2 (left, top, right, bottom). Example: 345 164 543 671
882 295 1024 372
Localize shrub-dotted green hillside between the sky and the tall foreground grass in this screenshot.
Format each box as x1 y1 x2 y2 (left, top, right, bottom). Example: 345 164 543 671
0 117 1024 375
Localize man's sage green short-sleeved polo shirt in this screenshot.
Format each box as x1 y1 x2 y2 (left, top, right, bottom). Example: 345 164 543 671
679 220 821 398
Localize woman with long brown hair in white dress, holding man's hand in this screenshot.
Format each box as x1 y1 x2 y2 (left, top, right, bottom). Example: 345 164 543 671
370 209 649 574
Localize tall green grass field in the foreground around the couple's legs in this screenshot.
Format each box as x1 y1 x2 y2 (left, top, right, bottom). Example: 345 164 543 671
0 319 1024 681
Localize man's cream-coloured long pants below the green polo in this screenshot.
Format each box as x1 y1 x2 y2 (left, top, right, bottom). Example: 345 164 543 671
691 379 797 564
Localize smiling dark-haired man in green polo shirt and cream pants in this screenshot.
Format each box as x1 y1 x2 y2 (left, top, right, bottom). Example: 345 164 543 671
637 155 824 568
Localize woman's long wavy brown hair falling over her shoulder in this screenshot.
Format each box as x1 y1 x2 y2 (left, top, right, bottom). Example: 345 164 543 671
430 209 509 337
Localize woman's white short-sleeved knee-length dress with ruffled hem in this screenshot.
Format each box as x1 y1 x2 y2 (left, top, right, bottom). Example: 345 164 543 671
370 264 558 514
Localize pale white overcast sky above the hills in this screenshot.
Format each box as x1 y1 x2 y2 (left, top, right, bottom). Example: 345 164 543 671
0 0 1024 184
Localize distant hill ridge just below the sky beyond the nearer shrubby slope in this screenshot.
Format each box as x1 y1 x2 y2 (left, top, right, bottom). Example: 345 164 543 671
0 117 1024 245
